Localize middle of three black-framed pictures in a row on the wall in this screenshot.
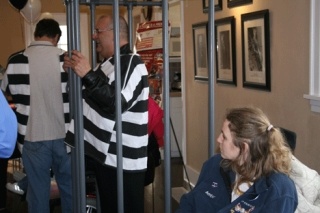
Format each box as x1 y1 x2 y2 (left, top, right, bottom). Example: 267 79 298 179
215 16 237 86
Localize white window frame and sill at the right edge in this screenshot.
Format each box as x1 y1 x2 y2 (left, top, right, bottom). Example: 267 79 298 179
303 0 320 113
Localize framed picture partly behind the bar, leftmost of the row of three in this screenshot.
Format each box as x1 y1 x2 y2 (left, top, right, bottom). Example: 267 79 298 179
192 22 208 80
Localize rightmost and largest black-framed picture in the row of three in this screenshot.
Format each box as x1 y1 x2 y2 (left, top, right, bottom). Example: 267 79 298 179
241 10 271 91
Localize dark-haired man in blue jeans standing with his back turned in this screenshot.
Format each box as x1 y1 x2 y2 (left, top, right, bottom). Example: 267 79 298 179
1 19 72 213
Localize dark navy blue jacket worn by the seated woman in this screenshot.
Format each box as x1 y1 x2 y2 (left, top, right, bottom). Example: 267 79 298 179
177 155 298 213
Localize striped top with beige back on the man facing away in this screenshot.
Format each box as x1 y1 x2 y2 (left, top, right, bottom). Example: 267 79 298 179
1 41 69 143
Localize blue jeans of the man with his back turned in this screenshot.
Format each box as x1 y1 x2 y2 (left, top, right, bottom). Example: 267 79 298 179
22 139 72 213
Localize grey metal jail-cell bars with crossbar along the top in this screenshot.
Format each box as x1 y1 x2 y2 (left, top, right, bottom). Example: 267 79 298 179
66 0 215 213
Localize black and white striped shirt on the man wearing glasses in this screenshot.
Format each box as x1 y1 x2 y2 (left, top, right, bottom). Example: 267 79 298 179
66 45 149 172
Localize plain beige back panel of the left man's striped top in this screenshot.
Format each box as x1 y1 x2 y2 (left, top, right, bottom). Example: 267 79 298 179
24 41 65 141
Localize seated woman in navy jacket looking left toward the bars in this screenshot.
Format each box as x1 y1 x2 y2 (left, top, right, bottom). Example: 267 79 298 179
177 107 298 213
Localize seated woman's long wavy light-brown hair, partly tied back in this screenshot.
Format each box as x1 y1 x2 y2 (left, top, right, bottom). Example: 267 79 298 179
221 107 292 191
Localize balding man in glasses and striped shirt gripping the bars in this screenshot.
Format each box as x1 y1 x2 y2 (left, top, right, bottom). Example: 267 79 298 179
64 15 149 213
